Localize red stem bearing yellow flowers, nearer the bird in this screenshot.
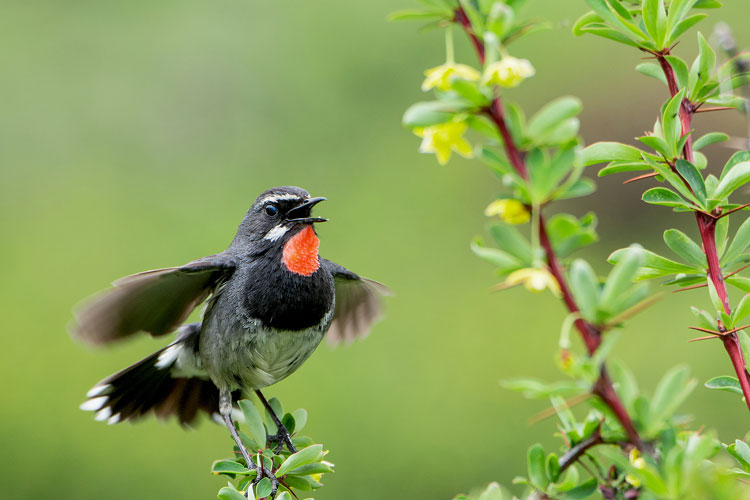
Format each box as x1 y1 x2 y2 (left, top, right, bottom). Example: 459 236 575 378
454 7 643 449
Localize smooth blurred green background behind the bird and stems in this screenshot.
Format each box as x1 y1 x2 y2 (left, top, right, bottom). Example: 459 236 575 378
0 0 750 500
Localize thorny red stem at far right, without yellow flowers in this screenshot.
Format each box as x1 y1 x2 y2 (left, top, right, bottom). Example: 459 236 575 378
654 51 750 410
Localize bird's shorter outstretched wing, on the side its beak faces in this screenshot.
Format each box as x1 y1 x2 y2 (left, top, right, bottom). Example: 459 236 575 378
321 259 391 344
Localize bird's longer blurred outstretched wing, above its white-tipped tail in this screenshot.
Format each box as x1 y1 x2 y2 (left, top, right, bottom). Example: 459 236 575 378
71 254 235 344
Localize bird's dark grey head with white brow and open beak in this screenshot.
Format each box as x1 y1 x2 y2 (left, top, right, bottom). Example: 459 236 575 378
235 186 328 252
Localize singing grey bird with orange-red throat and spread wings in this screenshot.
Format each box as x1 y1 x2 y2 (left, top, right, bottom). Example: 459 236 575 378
70 186 390 490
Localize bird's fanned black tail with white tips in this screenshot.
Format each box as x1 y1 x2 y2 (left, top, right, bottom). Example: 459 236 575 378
81 323 228 426
